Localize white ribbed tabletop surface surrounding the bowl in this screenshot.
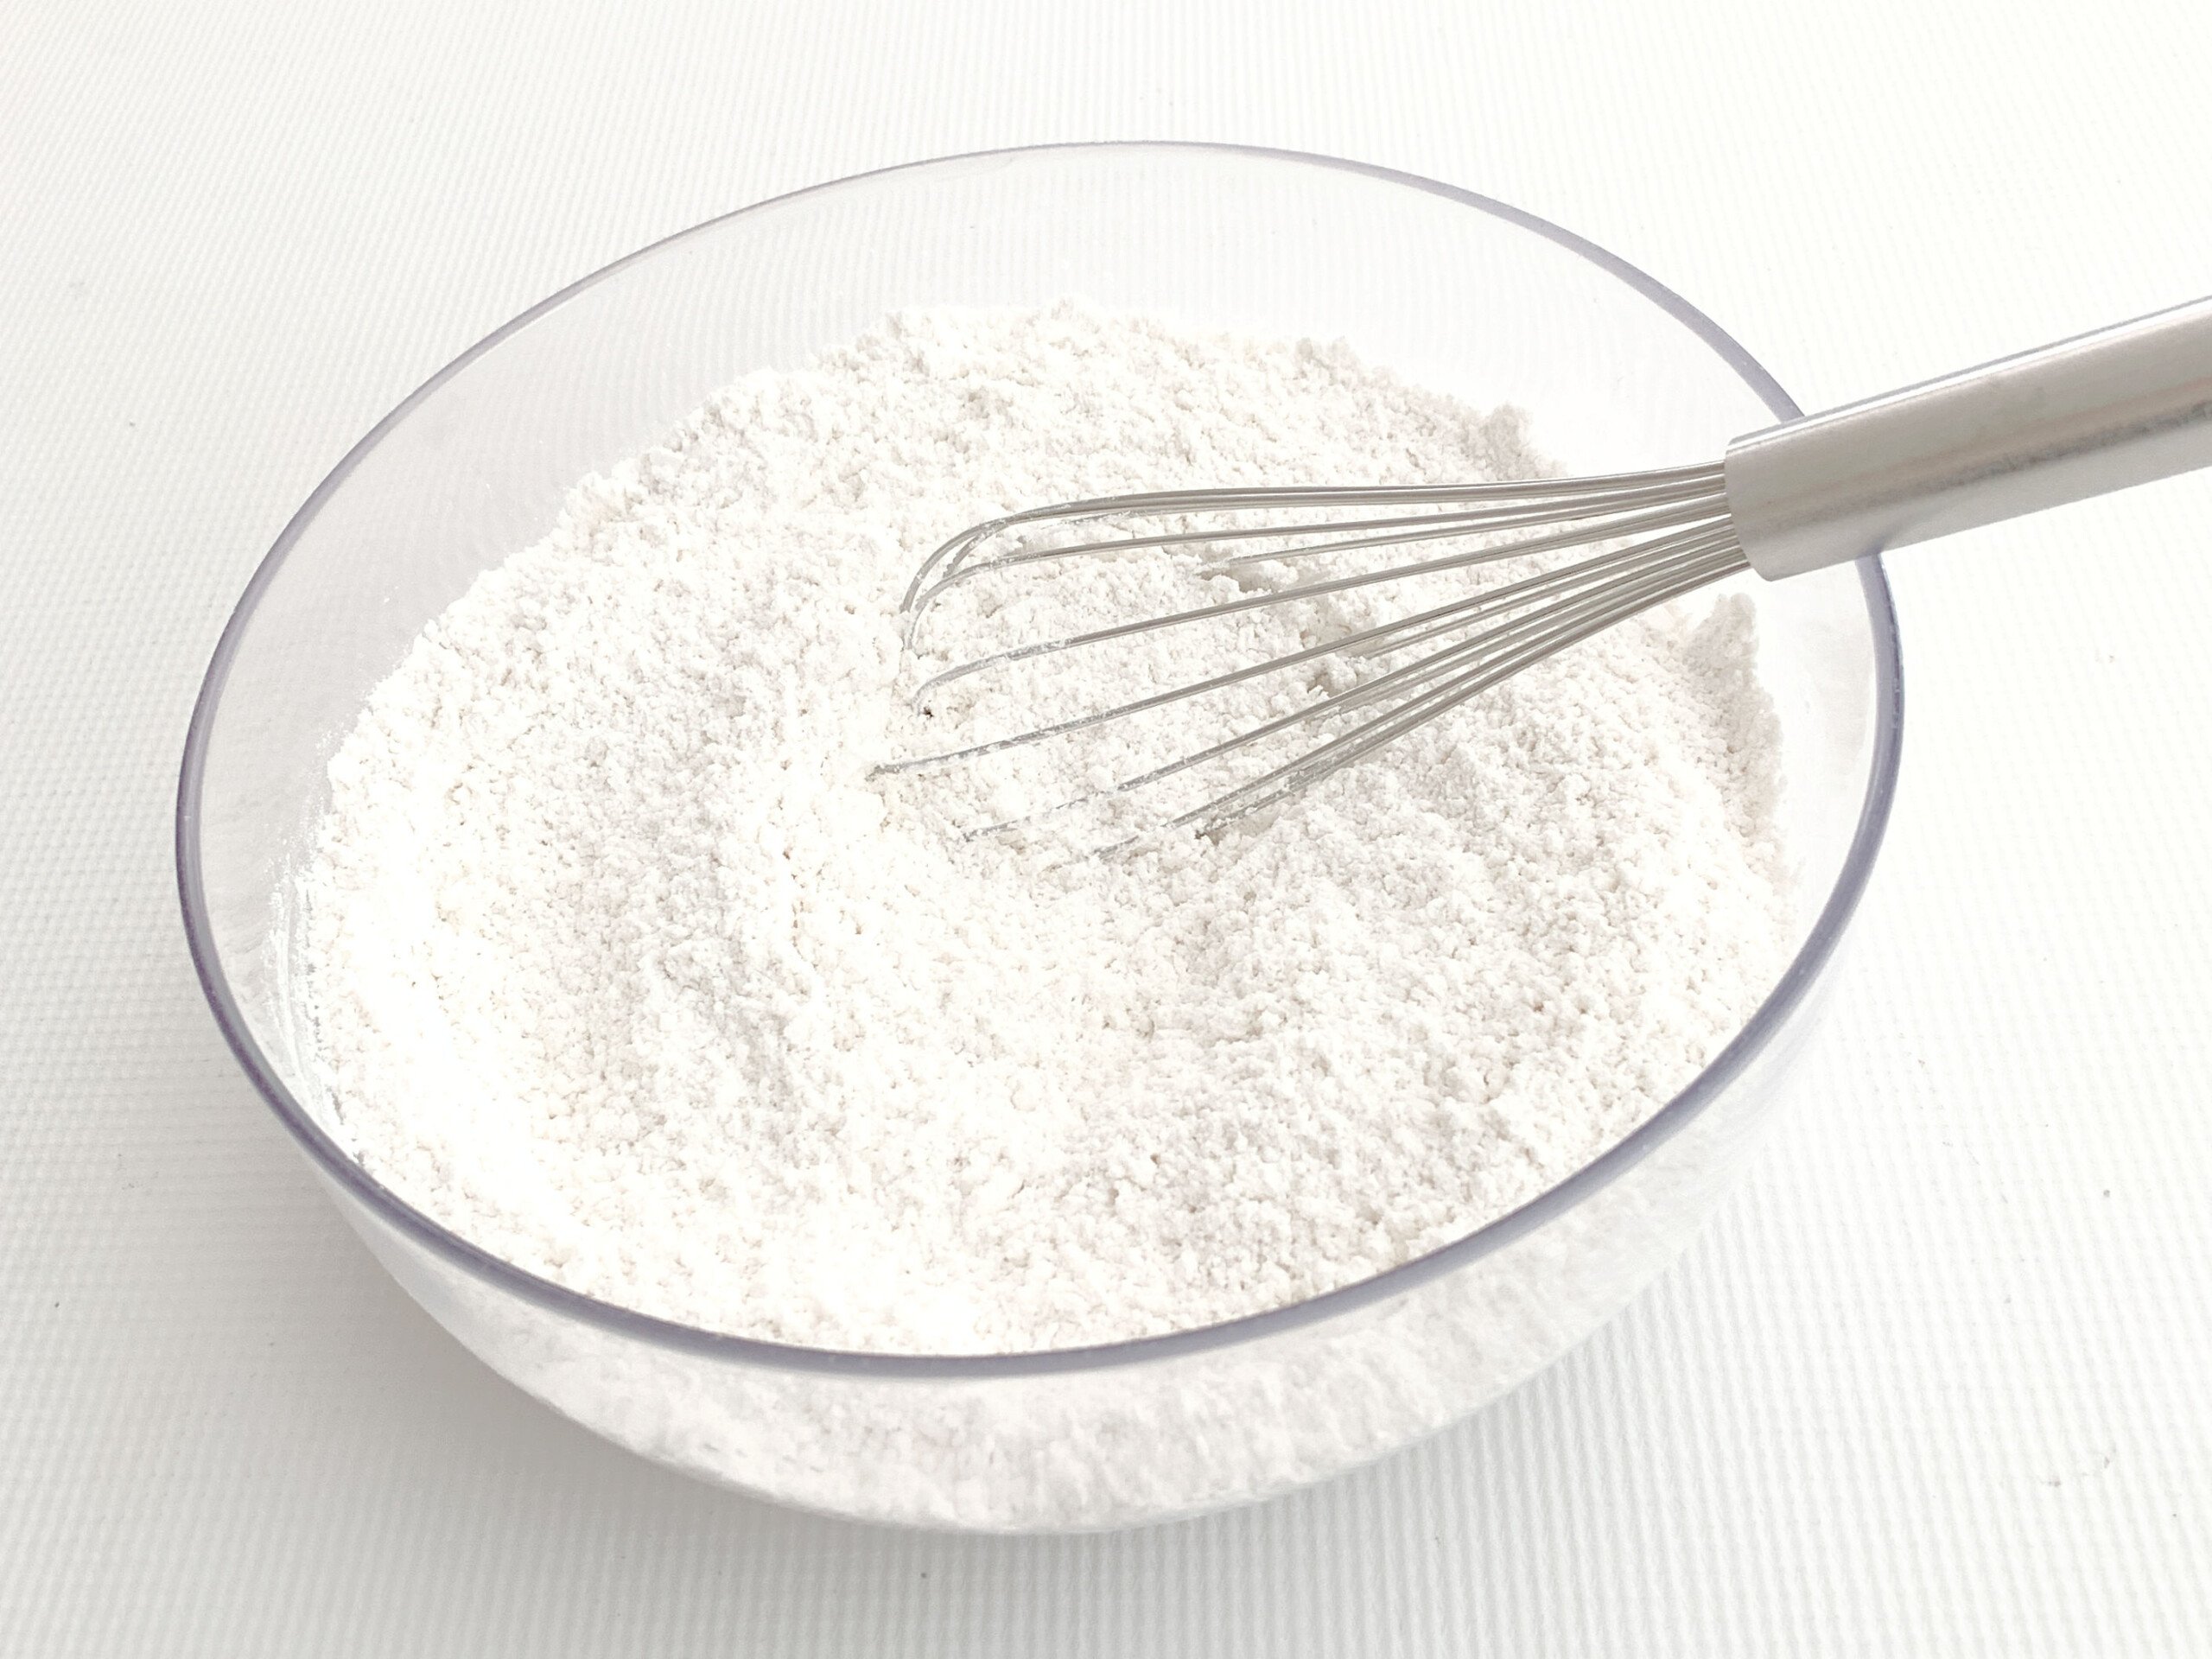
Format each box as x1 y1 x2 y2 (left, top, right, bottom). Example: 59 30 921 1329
0 0 2212 1656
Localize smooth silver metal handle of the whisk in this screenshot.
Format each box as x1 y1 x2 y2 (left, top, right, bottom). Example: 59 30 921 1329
1723 299 2212 580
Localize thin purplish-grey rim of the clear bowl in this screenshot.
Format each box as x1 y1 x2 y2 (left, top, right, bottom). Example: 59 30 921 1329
175 139 1904 1380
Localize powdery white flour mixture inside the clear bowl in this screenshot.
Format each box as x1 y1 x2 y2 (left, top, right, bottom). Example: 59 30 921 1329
305 303 1789 1354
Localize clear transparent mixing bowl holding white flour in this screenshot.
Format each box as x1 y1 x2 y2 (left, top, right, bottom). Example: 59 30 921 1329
177 143 1900 1531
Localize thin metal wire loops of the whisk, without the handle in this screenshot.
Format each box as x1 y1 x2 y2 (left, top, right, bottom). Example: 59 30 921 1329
876 467 1750 847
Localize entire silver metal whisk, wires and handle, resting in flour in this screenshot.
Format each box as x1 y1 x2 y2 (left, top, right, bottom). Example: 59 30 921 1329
878 299 2212 832
